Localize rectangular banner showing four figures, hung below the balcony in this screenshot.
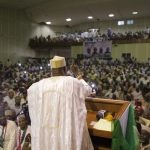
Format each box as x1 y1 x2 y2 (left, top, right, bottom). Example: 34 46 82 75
83 41 112 57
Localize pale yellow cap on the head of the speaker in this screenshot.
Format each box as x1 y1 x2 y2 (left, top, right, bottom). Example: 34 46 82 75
50 56 66 68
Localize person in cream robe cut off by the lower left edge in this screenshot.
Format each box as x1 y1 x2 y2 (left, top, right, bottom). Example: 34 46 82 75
0 107 17 150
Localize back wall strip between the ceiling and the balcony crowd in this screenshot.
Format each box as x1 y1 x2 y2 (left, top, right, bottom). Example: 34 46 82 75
29 17 150 37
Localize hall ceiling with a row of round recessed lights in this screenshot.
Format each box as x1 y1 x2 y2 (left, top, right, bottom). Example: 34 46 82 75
0 0 150 25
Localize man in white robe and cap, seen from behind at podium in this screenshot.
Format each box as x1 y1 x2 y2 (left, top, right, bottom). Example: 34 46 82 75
28 56 93 150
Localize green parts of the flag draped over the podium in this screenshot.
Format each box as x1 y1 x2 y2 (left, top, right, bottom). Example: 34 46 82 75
112 106 139 150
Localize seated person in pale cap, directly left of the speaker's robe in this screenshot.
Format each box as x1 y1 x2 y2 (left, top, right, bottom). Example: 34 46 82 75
16 114 31 150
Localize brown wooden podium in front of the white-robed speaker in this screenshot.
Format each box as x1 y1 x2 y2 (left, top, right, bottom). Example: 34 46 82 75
85 98 130 150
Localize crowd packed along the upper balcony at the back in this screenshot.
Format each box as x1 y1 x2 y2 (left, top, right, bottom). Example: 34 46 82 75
29 29 150 48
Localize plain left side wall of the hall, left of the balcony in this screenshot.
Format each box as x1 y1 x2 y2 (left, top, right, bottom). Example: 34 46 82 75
0 8 36 62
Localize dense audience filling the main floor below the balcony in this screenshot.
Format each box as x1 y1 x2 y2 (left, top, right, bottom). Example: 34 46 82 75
0 57 150 147
